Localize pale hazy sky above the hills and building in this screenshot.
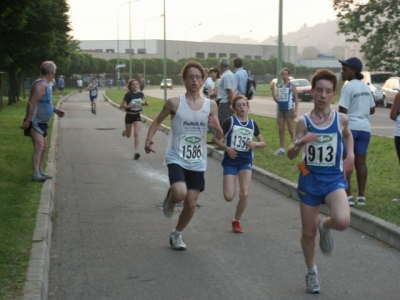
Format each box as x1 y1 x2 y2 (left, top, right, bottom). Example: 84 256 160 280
67 0 336 42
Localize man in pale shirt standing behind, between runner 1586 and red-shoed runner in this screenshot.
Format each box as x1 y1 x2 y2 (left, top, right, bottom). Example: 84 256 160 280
217 57 237 124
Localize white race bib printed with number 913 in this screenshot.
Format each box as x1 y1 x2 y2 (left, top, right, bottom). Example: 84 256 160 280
307 133 337 167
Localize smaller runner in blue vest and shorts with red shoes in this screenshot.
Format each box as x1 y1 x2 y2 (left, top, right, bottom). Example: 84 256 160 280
213 95 265 233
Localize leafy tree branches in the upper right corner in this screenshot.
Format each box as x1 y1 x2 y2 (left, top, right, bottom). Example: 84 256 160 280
333 0 400 70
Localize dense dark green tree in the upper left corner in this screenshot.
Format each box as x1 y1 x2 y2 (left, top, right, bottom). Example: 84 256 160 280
0 0 71 104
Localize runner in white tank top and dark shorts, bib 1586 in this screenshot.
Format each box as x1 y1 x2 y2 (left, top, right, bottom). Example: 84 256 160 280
145 61 223 250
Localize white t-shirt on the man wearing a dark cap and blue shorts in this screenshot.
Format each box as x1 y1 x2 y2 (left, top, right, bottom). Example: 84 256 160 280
339 79 375 132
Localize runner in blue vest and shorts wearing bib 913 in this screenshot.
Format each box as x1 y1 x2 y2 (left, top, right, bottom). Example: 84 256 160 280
287 69 354 293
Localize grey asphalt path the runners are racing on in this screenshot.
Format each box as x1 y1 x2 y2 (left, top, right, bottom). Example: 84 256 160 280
48 93 400 300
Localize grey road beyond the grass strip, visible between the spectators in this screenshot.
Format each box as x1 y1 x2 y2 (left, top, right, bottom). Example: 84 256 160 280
144 87 394 137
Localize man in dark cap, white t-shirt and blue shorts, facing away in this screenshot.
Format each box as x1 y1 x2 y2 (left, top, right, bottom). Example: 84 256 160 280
339 57 375 206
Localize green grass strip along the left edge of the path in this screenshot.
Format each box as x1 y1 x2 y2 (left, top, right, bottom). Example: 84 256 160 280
0 90 73 300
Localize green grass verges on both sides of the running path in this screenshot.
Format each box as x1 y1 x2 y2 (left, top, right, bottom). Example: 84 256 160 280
0 86 400 300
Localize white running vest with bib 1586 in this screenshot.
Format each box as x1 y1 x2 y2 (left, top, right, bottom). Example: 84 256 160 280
165 95 210 172
